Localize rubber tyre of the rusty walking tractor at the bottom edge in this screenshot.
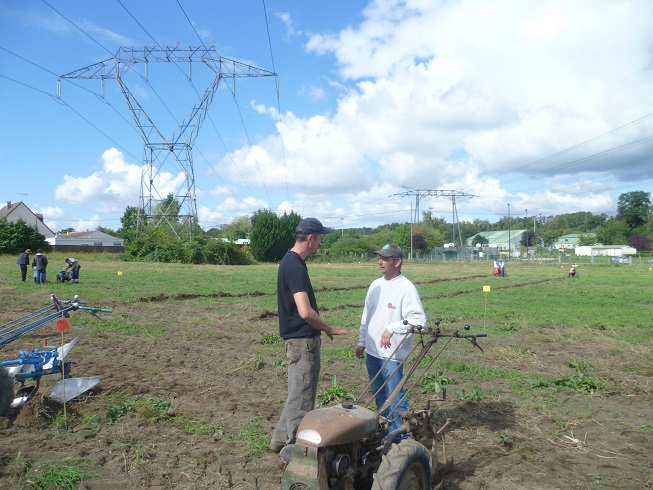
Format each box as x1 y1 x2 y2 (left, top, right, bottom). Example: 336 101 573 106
372 439 431 490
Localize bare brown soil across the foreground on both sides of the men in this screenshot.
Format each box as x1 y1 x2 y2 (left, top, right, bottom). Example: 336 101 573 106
0 282 653 489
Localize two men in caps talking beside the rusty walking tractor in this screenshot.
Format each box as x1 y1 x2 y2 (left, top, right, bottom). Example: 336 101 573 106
270 218 426 461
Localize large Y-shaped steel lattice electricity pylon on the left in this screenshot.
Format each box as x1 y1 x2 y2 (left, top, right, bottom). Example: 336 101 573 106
57 46 276 235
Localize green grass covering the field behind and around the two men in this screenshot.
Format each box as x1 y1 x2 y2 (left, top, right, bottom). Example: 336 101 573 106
0 254 653 488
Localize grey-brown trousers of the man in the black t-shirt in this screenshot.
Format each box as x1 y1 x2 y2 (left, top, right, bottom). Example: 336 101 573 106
270 337 321 447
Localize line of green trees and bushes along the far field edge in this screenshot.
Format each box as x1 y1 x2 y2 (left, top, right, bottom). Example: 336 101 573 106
0 191 653 265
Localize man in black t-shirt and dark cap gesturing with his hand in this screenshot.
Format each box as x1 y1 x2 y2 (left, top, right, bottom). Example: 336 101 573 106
270 218 349 461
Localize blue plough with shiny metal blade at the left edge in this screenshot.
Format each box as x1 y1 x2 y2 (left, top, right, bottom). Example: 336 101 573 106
0 295 112 416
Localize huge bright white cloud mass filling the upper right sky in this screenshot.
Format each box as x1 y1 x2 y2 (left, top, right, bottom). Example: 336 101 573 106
262 0 653 222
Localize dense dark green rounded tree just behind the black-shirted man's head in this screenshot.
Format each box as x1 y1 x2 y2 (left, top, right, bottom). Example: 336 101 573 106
250 209 301 262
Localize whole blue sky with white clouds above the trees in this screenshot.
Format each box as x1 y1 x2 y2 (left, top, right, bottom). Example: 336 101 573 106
0 0 653 232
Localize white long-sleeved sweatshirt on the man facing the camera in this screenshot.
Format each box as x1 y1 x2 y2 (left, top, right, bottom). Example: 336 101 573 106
358 274 426 361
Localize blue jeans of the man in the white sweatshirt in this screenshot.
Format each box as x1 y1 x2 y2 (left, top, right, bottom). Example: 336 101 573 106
365 354 409 432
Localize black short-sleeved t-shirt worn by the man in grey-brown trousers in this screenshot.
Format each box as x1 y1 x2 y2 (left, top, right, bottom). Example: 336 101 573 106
277 250 321 340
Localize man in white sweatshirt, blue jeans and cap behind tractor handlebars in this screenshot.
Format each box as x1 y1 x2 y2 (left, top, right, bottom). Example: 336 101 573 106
355 243 426 431
